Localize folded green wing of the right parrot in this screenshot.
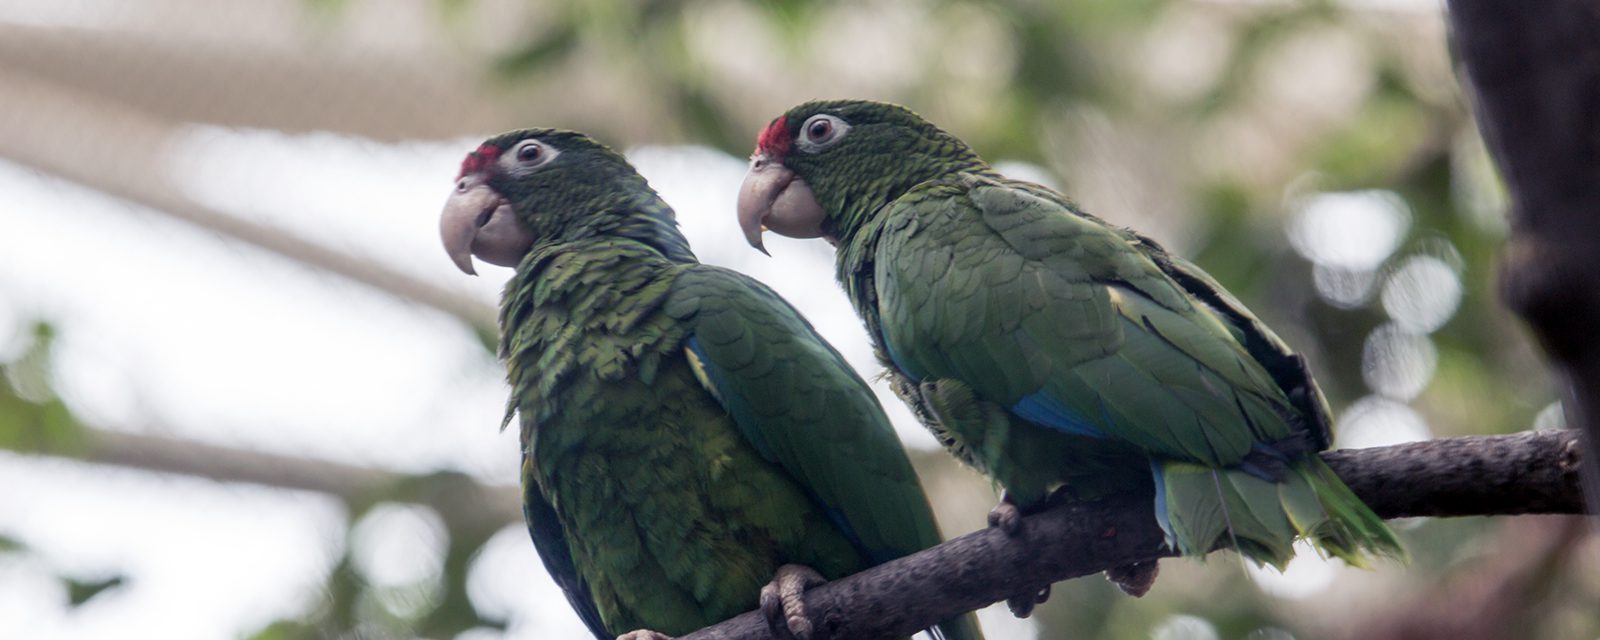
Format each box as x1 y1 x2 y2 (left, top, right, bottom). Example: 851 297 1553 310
877 176 1290 466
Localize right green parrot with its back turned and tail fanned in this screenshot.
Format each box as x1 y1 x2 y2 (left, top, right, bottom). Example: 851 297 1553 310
739 101 1403 595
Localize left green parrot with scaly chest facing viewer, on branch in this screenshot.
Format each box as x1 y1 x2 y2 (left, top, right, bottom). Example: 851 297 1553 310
440 130 981 640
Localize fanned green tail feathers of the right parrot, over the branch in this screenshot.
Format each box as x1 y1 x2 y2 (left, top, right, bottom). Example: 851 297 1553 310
1157 454 1405 570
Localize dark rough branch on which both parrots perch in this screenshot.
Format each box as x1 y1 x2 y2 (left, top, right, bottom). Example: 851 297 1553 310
680 430 1582 640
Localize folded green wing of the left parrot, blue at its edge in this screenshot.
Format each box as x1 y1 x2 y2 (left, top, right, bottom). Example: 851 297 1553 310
666 266 979 640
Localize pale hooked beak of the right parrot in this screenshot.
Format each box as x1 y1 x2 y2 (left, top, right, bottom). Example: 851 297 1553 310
739 154 827 253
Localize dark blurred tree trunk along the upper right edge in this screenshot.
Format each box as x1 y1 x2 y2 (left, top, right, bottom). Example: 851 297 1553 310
1450 0 1600 512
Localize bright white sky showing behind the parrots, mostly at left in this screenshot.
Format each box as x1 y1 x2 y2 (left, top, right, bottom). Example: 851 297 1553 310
0 128 1034 638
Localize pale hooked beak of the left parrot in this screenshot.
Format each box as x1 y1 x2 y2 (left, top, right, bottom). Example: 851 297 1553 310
438 173 533 275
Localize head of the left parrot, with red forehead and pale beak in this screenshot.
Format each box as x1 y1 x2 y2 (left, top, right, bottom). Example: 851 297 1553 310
440 130 694 274
